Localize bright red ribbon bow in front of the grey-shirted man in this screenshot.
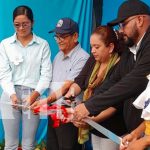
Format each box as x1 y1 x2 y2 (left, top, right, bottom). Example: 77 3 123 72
33 104 68 128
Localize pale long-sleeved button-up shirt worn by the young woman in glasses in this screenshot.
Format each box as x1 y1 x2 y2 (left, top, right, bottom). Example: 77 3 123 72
0 33 52 96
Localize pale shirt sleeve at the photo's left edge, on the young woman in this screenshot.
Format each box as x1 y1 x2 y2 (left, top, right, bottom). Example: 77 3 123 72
0 43 16 96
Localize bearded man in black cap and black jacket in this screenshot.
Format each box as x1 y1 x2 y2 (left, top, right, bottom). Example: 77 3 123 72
74 0 150 139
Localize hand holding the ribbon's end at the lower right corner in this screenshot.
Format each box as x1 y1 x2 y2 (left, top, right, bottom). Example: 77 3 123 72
120 133 137 150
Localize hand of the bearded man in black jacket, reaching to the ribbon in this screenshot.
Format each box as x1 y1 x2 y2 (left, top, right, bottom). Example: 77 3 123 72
74 103 89 121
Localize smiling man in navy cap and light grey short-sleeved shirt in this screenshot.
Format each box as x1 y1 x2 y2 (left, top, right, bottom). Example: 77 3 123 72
32 18 89 150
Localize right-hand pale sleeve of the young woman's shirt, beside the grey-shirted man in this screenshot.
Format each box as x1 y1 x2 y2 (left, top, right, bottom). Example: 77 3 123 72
35 42 52 94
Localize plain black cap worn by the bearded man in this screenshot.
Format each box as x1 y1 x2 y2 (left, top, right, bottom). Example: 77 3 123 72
108 0 150 26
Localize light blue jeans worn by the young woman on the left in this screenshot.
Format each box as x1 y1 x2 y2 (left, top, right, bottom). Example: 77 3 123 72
1 86 39 150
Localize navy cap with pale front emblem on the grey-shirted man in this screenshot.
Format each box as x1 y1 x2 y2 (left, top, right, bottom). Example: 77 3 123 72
49 18 79 34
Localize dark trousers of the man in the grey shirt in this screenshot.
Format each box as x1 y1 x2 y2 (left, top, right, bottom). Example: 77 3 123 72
47 117 82 150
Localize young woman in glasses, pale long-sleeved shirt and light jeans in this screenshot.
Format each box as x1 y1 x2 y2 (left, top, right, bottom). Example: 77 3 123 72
0 6 52 150
